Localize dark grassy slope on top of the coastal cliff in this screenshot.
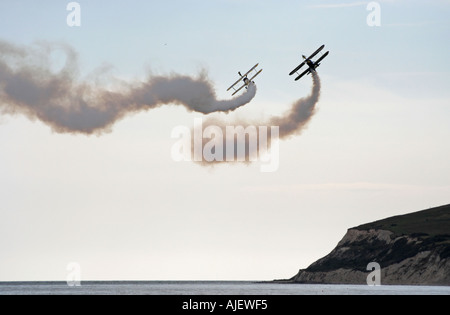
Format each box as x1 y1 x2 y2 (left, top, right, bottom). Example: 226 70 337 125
354 205 450 237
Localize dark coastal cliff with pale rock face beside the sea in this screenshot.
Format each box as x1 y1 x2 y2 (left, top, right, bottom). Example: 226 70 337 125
288 205 450 286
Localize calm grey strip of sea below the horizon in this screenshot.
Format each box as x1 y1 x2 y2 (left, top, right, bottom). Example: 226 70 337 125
0 281 450 295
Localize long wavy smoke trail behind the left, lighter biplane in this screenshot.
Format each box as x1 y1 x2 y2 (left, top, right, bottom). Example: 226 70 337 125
0 41 256 134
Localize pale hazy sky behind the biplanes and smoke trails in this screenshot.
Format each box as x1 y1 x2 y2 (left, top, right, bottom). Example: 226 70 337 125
0 0 450 281
